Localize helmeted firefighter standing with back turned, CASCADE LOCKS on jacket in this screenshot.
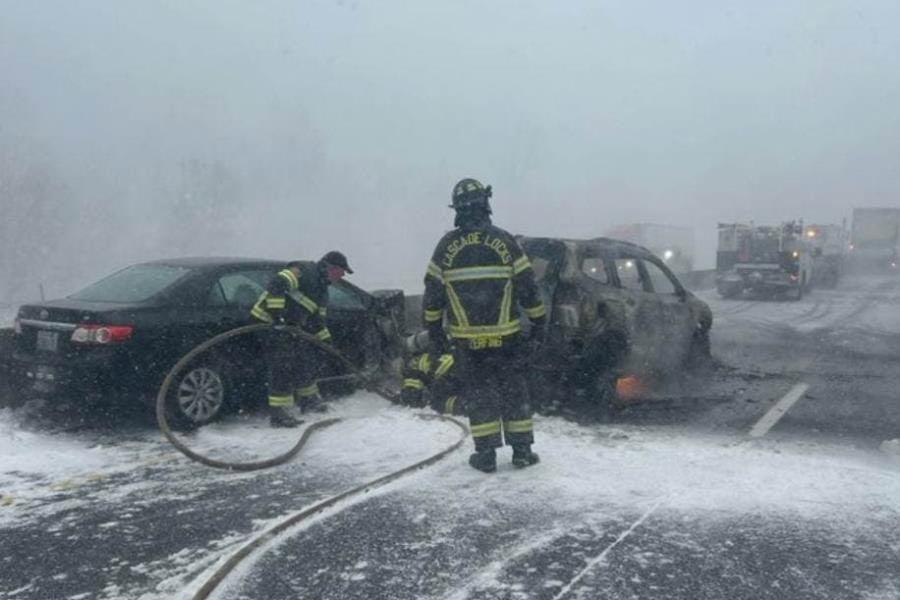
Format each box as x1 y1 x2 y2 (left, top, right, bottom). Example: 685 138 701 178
423 179 546 473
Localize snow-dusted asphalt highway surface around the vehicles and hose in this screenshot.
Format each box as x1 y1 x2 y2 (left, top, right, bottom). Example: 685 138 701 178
0 280 900 600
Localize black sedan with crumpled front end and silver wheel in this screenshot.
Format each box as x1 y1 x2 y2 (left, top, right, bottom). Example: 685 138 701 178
13 258 404 426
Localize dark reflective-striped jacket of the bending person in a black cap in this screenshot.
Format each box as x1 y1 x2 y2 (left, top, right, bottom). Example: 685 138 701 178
250 262 331 342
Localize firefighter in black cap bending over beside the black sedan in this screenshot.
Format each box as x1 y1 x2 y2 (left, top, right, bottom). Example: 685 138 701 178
251 252 353 427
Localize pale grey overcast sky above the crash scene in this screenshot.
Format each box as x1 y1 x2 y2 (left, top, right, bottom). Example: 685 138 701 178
0 0 900 300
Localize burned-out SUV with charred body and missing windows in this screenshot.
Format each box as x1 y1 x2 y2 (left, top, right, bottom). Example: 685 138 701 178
519 237 712 402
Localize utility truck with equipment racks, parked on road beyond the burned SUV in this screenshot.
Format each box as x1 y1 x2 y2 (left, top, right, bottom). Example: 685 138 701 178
716 221 814 300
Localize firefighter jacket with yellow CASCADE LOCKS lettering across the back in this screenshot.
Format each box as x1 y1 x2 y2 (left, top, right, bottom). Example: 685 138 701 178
423 221 547 350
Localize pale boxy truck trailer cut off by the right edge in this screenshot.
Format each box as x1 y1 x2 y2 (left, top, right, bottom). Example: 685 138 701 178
850 208 900 271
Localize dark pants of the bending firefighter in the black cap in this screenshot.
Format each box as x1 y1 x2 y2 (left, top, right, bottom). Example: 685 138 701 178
265 331 319 407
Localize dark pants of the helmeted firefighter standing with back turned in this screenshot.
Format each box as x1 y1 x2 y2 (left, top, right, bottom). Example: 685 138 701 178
459 344 534 451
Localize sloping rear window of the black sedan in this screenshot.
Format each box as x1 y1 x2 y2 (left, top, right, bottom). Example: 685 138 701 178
69 265 190 304
